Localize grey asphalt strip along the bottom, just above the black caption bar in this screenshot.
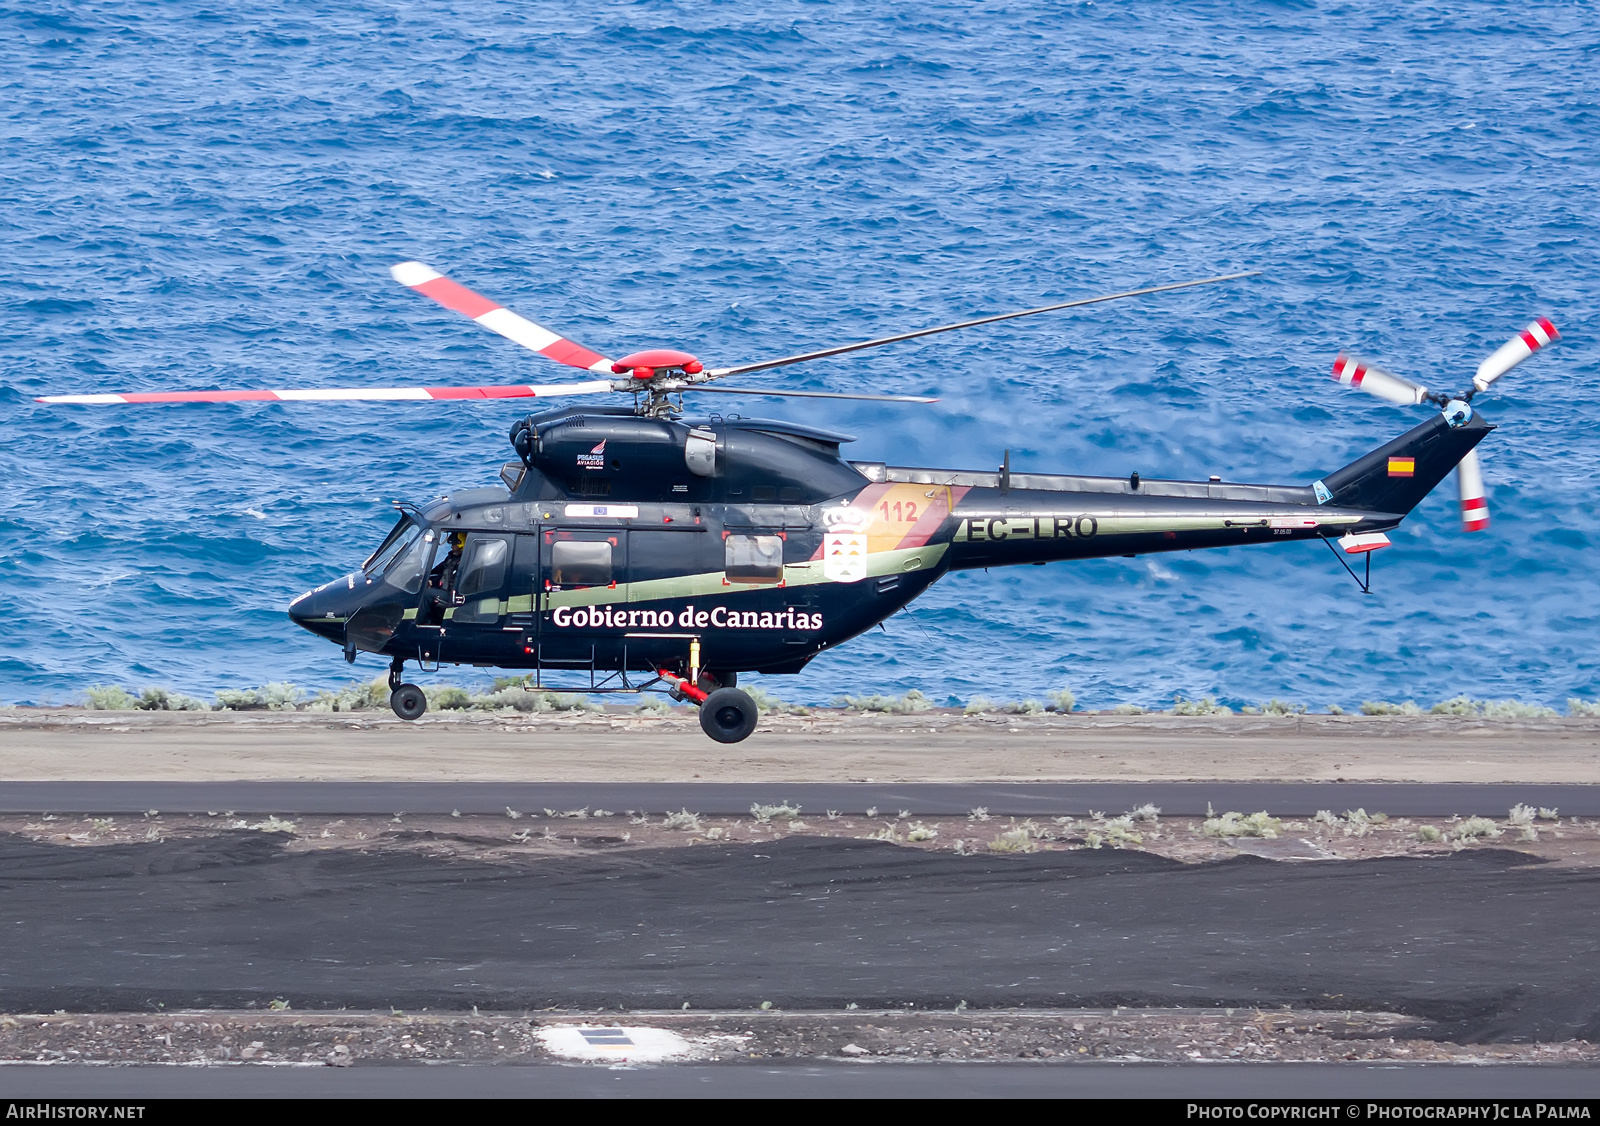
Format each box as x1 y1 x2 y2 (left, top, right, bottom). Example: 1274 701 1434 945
0 1064 1600 1112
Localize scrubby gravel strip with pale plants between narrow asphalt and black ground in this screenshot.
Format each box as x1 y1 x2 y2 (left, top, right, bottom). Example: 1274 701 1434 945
0 806 1600 867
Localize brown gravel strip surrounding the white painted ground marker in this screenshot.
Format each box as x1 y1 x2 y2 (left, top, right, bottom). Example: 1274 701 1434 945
0 1009 1600 1067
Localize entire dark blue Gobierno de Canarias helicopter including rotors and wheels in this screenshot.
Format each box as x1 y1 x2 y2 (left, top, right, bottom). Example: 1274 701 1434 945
37 262 1560 744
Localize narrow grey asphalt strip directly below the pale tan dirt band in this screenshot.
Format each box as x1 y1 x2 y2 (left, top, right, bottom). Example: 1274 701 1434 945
0 782 1600 817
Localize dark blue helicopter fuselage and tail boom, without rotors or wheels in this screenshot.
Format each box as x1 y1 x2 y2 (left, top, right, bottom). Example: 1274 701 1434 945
290 409 1490 688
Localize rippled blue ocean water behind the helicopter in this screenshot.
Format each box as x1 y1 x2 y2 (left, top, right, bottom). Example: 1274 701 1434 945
0 0 1600 707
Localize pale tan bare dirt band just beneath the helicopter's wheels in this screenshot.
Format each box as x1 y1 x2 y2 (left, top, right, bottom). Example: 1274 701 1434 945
0 707 1600 783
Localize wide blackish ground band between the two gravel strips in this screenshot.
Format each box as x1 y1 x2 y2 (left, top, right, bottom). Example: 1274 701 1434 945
0 832 1600 1041
